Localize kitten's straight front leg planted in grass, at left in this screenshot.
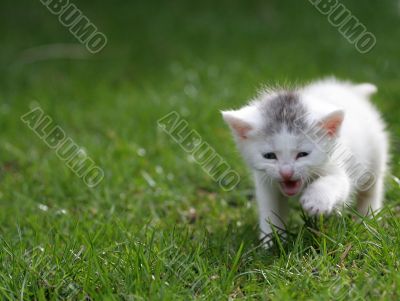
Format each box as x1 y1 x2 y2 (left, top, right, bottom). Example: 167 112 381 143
255 174 288 240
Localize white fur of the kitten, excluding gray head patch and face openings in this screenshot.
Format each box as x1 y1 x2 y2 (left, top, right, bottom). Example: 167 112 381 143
222 79 389 241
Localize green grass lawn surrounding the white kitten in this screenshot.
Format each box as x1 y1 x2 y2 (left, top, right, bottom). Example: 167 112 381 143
0 0 400 300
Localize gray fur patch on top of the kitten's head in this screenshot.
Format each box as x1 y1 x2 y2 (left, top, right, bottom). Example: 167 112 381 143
260 91 307 135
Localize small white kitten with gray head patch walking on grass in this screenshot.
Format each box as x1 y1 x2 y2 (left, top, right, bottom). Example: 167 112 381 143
222 78 389 238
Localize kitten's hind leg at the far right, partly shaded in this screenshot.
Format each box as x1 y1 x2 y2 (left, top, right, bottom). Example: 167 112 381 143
357 174 384 215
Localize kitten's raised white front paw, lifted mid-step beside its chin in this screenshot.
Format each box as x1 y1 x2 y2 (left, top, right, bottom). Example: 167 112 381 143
300 169 351 215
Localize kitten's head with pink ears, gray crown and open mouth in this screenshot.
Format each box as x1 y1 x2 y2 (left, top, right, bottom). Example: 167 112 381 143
222 91 343 196
